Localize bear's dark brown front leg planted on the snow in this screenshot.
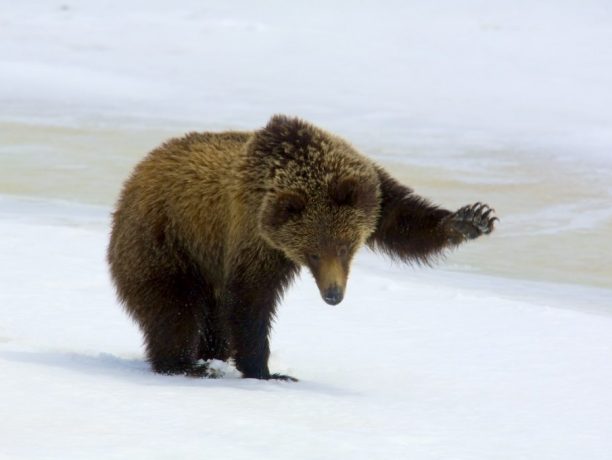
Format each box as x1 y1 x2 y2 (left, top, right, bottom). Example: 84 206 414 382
226 252 297 381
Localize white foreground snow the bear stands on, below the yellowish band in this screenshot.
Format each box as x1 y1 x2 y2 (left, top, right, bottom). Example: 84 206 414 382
0 198 612 460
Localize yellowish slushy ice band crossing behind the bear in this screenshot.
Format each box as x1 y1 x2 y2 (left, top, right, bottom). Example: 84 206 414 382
0 123 612 288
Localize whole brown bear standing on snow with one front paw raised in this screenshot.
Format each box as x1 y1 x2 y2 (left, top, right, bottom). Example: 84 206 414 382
108 115 496 380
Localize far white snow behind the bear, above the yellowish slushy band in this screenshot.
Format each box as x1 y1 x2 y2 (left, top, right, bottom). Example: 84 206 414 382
0 0 612 164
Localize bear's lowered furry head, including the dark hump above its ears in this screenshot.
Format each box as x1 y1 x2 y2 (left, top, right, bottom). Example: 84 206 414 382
250 115 380 305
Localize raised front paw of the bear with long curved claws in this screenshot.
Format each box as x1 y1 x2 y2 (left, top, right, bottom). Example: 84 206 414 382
444 202 499 243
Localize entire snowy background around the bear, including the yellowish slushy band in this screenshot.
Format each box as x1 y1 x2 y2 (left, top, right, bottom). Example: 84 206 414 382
0 0 612 460
